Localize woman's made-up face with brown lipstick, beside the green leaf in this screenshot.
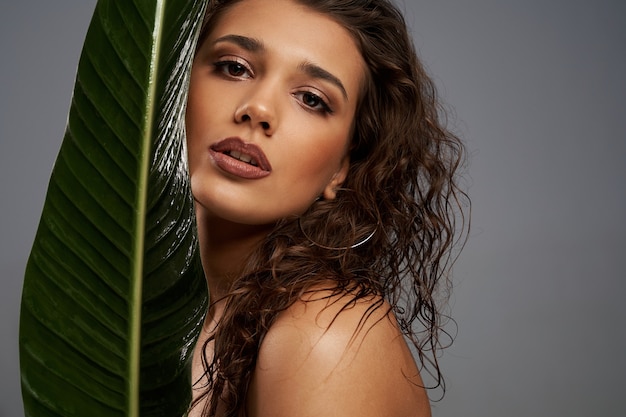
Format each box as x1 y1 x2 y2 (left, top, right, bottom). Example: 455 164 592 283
186 0 365 225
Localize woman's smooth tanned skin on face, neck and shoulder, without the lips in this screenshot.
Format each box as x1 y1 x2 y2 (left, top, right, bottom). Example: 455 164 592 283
186 0 430 417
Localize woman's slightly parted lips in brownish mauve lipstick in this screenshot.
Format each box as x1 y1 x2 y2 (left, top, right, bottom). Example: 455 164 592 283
209 137 272 179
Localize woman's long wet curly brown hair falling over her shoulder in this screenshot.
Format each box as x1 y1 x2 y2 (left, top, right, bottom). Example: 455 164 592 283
194 0 468 416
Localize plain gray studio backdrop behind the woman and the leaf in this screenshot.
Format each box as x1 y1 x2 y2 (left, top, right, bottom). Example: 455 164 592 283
0 0 626 417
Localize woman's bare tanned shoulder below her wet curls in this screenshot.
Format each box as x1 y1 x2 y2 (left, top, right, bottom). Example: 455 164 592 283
248 291 430 417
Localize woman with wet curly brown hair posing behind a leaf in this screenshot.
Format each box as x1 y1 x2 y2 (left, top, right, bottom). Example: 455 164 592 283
187 0 462 417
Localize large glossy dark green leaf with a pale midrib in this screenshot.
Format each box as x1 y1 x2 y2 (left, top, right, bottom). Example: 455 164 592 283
20 0 207 417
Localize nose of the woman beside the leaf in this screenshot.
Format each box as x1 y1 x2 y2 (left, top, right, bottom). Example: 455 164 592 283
235 84 277 136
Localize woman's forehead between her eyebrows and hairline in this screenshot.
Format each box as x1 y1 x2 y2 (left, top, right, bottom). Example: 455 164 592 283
205 0 365 99
